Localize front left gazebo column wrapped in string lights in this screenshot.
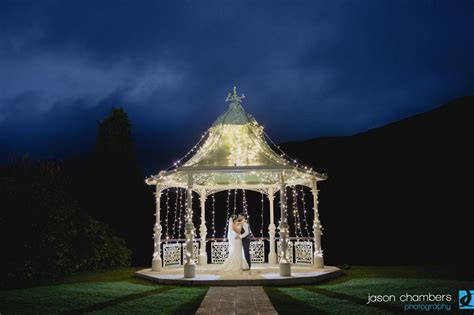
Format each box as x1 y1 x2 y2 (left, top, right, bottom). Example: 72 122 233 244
184 174 196 278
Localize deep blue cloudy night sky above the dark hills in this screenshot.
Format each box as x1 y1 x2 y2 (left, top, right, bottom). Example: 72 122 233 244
0 0 474 175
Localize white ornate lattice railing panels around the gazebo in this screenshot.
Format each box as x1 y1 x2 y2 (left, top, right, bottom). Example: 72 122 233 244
161 237 314 266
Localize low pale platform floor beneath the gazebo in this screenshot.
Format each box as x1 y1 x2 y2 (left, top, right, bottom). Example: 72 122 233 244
135 264 342 286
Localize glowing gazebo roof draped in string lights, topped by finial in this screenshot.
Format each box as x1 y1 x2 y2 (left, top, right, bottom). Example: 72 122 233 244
146 88 326 191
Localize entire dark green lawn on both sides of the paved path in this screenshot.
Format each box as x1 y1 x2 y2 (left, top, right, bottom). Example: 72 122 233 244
0 266 474 315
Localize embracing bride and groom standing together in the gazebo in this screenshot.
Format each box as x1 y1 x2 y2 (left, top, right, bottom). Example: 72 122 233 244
220 213 252 273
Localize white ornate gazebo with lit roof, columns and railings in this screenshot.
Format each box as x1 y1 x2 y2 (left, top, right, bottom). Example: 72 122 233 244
145 87 327 278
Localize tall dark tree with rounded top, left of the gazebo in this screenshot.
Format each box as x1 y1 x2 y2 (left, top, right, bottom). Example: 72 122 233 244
68 108 153 265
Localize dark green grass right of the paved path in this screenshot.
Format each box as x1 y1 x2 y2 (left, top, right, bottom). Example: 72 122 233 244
265 266 474 314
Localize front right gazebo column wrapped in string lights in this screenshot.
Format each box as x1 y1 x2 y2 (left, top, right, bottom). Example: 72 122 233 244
278 172 291 277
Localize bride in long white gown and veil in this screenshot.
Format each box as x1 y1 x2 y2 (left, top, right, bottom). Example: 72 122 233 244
219 214 249 272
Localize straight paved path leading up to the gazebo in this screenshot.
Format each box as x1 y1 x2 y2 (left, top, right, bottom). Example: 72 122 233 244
196 286 278 315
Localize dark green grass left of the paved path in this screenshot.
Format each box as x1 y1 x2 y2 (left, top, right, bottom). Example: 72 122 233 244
0 268 207 314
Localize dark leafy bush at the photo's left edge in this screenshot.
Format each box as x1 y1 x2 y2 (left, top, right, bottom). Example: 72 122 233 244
0 159 131 287
